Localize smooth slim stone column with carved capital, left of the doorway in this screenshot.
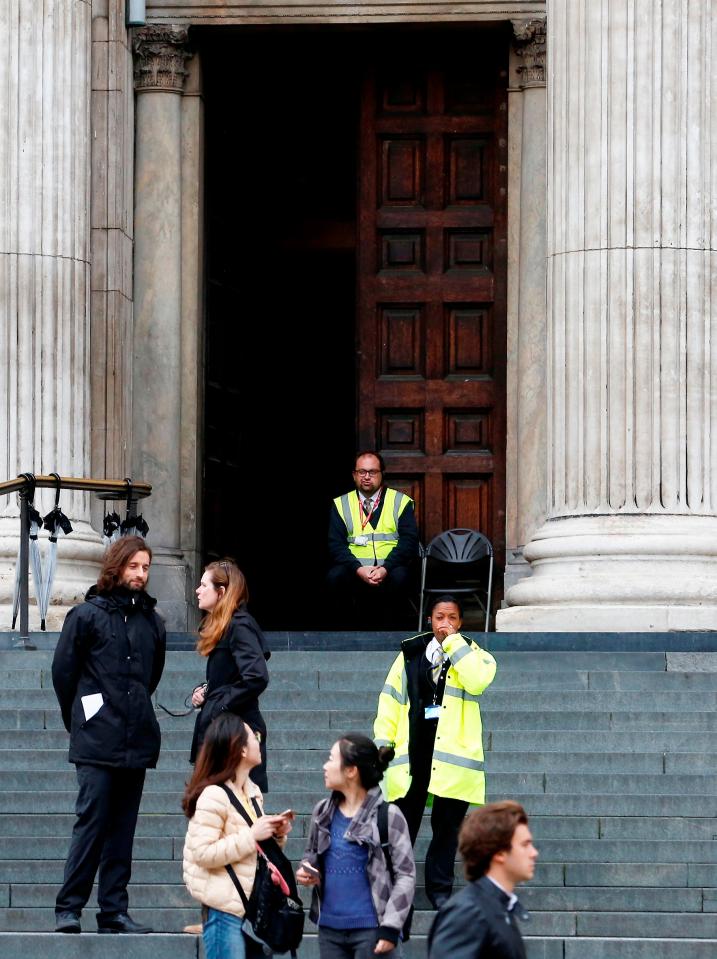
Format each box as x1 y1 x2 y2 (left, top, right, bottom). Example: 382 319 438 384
132 26 190 630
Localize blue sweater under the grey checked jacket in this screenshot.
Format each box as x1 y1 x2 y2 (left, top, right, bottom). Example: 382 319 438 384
319 809 378 929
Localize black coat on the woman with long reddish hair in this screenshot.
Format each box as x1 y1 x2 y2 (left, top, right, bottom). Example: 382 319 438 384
189 606 271 793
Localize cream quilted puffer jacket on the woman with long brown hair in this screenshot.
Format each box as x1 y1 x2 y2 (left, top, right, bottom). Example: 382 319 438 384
183 779 263 916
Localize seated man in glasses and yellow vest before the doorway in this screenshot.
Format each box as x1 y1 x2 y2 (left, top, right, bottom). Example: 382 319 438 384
328 451 418 628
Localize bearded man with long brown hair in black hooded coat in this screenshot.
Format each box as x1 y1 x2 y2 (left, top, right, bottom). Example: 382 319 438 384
52 536 166 933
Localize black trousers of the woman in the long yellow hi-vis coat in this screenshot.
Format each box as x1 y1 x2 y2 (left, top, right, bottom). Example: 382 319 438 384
394 763 469 906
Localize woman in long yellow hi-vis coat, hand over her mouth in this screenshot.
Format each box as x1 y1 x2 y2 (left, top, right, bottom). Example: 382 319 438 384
374 595 496 909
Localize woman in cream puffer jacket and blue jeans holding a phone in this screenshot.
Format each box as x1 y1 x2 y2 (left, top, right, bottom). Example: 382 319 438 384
182 712 291 959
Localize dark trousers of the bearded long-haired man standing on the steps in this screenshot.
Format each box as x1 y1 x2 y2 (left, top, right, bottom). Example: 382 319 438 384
55 763 145 916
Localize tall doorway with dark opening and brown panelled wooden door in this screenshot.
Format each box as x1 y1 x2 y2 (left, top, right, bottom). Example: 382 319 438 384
196 25 509 630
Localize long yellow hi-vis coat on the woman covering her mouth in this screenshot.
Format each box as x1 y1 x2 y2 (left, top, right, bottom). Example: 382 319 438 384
373 633 496 805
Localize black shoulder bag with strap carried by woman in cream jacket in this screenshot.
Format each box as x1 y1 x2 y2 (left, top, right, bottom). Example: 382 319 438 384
222 784 304 957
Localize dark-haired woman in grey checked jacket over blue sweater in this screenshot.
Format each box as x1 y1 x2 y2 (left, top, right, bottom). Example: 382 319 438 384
296 733 416 959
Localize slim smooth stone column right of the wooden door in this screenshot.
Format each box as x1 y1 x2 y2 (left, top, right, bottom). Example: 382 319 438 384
505 18 547 589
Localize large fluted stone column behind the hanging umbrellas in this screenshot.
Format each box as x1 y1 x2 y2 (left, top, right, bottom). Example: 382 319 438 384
0 0 103 629
